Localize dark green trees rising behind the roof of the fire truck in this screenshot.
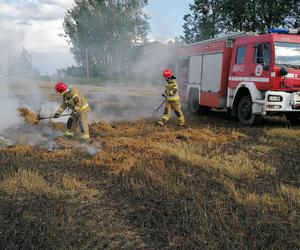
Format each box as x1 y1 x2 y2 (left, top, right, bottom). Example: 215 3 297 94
182 0 300 43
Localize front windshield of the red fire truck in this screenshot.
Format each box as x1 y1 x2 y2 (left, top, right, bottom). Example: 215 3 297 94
275 42 300 68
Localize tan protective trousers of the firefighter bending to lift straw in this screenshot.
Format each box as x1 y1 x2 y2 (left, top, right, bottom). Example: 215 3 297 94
65 112 90 140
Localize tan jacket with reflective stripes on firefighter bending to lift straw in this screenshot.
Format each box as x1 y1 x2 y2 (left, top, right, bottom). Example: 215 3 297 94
56 88 90 114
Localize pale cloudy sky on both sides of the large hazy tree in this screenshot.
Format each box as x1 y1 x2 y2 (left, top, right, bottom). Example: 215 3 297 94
0 0 194 75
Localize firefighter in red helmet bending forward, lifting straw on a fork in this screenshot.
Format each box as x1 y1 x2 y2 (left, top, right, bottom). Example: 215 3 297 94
54 82 90 141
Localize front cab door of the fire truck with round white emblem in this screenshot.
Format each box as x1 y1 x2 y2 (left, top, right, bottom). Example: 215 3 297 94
250 43 271 89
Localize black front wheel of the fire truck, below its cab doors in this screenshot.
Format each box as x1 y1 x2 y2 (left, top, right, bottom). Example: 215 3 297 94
237 96 261 125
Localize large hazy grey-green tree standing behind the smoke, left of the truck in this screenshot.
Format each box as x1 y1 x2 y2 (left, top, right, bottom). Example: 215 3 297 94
64 0 149 74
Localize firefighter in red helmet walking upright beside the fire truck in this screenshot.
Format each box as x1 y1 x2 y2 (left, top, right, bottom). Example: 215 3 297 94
157 69 185 126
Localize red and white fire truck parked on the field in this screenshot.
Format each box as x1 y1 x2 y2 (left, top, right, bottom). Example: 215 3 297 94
176 28 300 125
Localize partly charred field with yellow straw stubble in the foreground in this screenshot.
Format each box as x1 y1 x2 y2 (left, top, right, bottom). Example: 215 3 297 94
0 111 300 249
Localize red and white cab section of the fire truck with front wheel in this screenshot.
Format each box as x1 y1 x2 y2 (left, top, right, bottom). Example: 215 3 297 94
227 33 300 125
